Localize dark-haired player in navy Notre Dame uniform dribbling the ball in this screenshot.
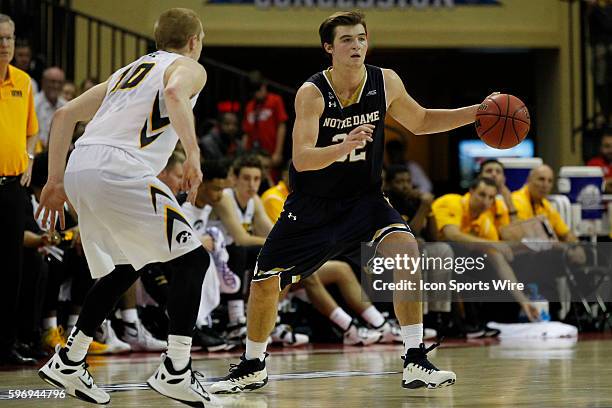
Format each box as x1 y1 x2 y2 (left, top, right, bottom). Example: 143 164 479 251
210 12 486 393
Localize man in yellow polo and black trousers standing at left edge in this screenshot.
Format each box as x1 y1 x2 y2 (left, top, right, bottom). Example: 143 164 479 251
0 14 38 365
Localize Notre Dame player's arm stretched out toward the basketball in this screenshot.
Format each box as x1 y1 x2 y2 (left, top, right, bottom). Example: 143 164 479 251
383 69 479 135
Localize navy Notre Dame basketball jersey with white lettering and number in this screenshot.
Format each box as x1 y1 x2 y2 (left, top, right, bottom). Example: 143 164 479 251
289 65 387 198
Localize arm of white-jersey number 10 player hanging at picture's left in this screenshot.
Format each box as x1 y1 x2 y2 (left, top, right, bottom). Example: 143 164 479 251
35 82 107 231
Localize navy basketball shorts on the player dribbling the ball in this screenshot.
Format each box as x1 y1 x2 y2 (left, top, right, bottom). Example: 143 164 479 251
253 192 411 289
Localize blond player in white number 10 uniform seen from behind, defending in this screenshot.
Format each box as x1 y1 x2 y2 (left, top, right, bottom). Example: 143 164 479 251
38 8 218 406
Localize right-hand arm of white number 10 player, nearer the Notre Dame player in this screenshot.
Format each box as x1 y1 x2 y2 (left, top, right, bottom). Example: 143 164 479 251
164 58 206 204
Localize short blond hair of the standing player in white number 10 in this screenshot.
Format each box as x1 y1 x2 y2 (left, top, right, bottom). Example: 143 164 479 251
153 8 202 50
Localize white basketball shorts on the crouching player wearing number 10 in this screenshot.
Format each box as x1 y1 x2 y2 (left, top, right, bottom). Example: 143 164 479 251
64 145 202 278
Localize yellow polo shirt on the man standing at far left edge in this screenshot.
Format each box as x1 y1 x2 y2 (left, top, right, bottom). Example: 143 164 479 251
0 65 38 176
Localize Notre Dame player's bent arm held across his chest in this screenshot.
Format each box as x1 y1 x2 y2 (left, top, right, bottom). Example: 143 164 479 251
293 83 374 171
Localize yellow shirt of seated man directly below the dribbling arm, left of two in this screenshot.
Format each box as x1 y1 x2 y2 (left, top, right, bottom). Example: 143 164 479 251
431 193 499 241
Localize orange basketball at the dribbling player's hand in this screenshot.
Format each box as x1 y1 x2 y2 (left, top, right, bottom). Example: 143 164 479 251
476 94 531 149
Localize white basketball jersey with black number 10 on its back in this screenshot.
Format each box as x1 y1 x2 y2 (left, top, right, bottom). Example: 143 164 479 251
75 51 198 175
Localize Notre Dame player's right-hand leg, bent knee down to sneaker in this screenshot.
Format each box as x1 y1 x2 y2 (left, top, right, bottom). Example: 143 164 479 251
377 231 456 388
